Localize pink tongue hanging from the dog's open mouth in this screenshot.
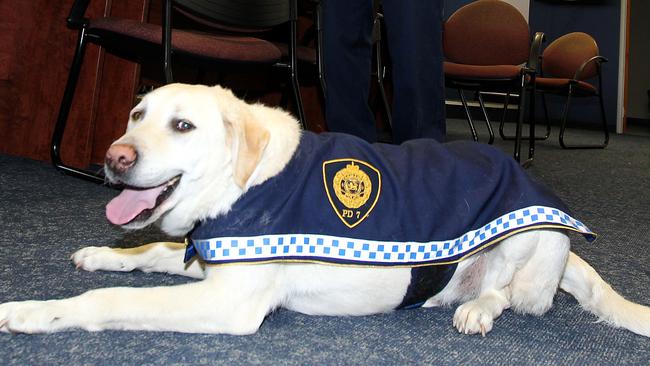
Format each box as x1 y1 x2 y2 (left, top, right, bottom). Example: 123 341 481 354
106 185 165 225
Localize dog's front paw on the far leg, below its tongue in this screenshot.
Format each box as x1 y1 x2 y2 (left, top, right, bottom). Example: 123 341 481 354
71 247 135 272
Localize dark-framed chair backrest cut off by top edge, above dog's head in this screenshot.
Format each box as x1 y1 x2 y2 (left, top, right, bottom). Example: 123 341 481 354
173 0 296 30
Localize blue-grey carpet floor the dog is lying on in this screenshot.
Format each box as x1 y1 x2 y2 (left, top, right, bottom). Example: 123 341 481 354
0 121 650 365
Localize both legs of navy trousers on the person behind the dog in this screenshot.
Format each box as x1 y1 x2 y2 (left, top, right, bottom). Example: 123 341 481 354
323 0 446 143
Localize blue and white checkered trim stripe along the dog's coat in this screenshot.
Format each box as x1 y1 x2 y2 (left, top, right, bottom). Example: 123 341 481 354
188 206 596 265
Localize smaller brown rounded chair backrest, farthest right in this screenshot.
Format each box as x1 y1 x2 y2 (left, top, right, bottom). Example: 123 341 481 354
542 32 598 80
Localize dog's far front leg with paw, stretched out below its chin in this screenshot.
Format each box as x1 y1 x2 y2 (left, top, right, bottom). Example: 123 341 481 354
71 242 205 279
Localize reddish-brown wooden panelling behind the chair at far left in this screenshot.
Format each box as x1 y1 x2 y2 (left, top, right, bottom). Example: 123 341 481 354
0 0 148 167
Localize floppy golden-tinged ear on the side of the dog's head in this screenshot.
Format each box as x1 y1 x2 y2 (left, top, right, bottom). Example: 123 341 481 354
219 88 270 189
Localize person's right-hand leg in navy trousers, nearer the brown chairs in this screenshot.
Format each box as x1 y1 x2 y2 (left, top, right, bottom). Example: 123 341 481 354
383 0 446 143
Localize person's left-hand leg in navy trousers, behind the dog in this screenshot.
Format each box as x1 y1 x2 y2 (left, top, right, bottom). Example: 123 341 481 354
323 0 377 142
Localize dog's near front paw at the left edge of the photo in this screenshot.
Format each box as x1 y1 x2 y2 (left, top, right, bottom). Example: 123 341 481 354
0 301 63 333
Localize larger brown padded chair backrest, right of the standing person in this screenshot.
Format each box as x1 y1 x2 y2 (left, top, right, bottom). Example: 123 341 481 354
443 0 530 65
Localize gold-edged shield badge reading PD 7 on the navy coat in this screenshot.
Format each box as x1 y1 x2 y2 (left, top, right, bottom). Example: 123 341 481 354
323 159 381 228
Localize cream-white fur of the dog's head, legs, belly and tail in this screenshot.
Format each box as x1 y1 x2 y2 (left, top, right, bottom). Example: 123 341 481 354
0 84 650 336
